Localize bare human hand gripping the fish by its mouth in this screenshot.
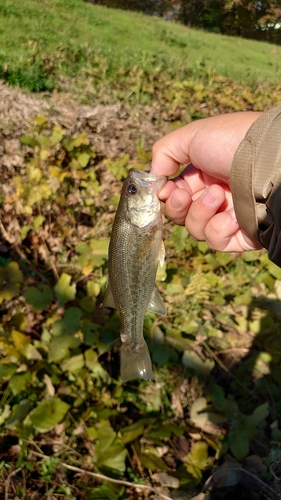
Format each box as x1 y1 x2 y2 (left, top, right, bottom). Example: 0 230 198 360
151 112 261 252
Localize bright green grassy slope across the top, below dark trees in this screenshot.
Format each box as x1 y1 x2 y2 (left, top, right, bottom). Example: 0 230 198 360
0 0 281 90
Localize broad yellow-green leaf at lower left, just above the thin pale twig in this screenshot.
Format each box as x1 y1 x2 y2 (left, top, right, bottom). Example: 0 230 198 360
29 397 70 432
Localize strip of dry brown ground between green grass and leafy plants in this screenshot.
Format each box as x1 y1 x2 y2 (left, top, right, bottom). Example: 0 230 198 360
0 79 173 175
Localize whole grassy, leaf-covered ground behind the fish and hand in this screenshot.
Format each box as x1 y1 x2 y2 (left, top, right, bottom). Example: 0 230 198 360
0 0 281 500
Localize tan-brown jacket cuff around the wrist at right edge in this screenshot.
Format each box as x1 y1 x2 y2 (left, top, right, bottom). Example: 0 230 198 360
230 105 281 267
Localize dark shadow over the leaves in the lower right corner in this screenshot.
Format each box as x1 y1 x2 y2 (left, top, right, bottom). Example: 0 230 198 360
207 296 281 500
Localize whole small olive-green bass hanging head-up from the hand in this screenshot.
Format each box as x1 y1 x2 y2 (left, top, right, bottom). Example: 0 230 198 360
102 168 167 382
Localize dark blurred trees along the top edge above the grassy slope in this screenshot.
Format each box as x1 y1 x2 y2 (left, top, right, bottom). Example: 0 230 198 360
86 0 281 45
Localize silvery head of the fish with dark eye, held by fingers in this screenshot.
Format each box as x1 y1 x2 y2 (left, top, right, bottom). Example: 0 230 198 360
122 168 167 228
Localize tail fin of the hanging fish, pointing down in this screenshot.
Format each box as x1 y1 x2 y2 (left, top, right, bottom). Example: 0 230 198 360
120 340 154 382
